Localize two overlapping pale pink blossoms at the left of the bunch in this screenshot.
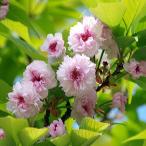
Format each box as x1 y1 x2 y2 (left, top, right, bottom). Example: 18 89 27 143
7 60 56 118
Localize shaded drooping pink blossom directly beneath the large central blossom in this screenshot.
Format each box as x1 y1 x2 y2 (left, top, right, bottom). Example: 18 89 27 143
72 90 97 122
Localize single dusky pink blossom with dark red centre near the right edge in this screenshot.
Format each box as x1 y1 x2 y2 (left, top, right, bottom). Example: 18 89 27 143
124 59 143 78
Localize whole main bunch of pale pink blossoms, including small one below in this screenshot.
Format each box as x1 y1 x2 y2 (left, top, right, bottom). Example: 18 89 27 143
7 16 119 123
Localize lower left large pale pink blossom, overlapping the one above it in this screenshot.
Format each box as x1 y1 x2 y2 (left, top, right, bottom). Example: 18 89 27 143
7 81 42 118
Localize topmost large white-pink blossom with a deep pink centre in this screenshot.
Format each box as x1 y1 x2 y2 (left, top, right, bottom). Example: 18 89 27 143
68 16 99 57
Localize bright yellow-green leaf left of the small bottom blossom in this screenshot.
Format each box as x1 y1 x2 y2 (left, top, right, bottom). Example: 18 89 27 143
19 127 48 146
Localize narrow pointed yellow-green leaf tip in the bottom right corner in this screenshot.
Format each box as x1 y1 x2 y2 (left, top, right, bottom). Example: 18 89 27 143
123 130 146 143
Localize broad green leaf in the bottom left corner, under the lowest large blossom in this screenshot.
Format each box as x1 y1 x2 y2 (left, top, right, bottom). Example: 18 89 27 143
0 116 28 146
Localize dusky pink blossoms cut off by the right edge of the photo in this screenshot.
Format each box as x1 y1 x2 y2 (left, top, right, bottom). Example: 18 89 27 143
124 59 146 79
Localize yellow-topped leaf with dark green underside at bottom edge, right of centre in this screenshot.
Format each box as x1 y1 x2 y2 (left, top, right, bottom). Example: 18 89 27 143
71 129 101 146
